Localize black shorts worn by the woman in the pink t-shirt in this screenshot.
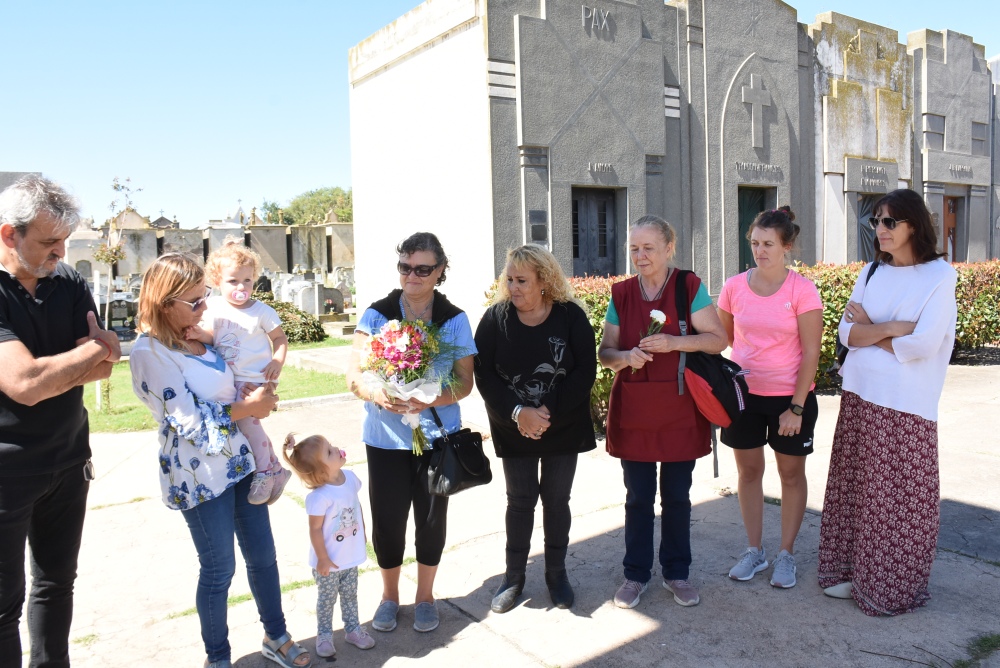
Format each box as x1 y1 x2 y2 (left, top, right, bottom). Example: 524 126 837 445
720 392 819 456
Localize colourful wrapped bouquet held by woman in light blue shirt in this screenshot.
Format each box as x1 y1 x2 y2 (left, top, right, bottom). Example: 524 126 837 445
361 320 444 455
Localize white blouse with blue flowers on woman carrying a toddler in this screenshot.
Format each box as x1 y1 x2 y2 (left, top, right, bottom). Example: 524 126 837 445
129 336 256 510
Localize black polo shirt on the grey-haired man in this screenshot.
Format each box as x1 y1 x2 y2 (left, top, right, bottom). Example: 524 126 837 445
0 262 97 476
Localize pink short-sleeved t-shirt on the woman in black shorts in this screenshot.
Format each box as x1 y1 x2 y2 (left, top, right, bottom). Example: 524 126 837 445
719 270 823 397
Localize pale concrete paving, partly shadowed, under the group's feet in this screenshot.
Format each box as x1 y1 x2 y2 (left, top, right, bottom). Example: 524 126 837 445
22 349 1000 668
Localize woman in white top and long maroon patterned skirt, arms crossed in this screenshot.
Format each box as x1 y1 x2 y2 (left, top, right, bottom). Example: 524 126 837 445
819 190 956 615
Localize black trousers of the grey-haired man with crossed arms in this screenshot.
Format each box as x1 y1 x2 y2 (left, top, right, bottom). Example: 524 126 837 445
0 464 90 668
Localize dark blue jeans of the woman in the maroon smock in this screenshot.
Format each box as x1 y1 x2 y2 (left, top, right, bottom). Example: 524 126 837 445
622 459 694 582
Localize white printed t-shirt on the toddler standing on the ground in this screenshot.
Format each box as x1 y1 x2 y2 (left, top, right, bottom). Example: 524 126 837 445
306 469 368 570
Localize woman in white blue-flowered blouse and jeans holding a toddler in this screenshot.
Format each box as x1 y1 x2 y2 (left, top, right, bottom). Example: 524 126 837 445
129 253 312 668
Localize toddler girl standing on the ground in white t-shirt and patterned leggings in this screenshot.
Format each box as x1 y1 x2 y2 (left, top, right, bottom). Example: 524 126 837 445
284 434 375 657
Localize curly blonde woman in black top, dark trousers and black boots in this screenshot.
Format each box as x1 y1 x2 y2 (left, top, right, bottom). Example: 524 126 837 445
476 244 597 613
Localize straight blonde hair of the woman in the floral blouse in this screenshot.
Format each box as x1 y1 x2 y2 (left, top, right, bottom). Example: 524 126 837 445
136 253 205 348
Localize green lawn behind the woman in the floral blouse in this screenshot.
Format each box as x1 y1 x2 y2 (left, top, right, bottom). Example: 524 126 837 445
83 362 347 433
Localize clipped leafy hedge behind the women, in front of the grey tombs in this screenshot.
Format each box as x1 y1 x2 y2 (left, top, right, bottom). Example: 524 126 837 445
564 260 1000 431
